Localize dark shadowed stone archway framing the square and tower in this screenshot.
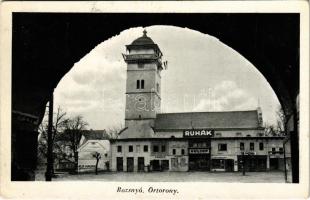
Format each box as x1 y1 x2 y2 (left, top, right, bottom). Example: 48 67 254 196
12 13 299 180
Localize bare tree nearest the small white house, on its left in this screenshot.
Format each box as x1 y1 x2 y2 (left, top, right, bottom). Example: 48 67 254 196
64 115 88 171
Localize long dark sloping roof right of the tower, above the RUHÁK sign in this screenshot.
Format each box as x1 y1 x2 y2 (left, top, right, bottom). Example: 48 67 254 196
155 110 259 130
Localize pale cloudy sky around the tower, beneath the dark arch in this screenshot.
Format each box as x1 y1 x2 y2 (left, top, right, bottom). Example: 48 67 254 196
54 26 280 129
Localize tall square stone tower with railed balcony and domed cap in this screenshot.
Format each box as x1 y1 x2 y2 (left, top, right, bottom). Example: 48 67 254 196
123 30 166 127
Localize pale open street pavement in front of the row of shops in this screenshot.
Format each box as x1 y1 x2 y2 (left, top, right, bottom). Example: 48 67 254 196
36 171 285 183
